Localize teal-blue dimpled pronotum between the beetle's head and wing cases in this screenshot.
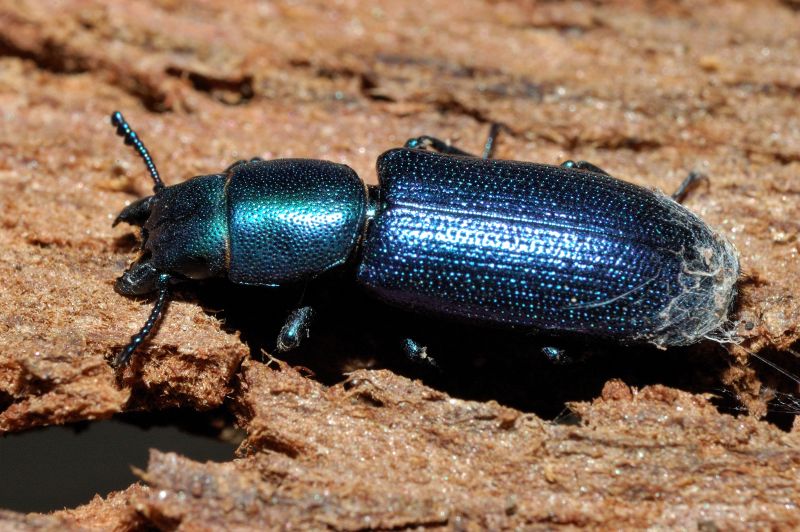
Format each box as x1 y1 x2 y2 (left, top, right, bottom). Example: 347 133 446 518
226 159 367 285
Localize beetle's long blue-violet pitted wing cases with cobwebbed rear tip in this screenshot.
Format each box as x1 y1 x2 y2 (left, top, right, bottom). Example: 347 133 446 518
358 148 739 346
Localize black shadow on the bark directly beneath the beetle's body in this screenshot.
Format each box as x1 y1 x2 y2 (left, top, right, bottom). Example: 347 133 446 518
193 275 756 419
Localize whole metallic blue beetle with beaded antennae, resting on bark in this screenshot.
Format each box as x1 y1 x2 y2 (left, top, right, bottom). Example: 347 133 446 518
111 112 739 367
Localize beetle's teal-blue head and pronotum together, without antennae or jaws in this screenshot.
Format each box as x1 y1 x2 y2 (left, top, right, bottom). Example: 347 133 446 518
143 159 367 285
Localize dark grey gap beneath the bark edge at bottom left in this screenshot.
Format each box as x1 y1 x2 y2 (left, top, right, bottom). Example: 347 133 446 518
0 410 240 512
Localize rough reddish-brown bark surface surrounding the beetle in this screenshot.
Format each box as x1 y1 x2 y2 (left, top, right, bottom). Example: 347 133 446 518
0 0 800 530
